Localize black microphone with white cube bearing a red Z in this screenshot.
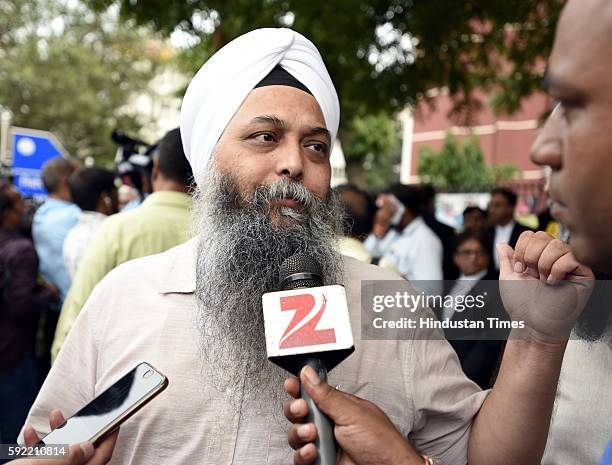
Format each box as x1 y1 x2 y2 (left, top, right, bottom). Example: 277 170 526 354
262 253 355 465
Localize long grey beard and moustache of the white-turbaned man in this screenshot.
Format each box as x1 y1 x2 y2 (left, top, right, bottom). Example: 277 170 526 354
194 167 343 413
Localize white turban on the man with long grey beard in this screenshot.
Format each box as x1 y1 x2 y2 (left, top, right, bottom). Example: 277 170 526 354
181 28 340 182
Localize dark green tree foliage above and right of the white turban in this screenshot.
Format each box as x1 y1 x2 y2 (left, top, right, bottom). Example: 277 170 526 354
89 0 564 124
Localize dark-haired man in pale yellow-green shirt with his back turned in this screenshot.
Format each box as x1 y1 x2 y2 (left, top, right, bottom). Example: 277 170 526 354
51 129 193 360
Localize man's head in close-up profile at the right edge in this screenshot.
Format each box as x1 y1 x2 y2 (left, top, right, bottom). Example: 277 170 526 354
531 0 612 270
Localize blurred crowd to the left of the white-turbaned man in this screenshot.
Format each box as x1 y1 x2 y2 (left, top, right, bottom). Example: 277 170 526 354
0 129 192 454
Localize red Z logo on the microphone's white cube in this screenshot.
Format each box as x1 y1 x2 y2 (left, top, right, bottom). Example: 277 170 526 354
279 294 336 349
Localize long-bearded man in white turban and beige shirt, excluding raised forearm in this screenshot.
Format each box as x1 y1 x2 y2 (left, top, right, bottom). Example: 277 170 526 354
16 29 592 465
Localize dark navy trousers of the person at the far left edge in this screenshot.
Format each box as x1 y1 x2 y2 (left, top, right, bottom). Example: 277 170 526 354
0 354 39 448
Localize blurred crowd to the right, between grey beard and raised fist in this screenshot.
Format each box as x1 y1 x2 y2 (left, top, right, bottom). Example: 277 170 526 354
336 184 547 389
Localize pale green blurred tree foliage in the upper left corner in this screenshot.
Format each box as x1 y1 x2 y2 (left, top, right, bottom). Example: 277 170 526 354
0 0 160 164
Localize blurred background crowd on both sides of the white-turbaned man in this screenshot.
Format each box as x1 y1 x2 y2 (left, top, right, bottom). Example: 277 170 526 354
0 144 544 442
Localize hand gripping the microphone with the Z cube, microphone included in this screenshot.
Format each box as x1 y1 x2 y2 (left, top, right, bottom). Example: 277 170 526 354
262 254 424 465
